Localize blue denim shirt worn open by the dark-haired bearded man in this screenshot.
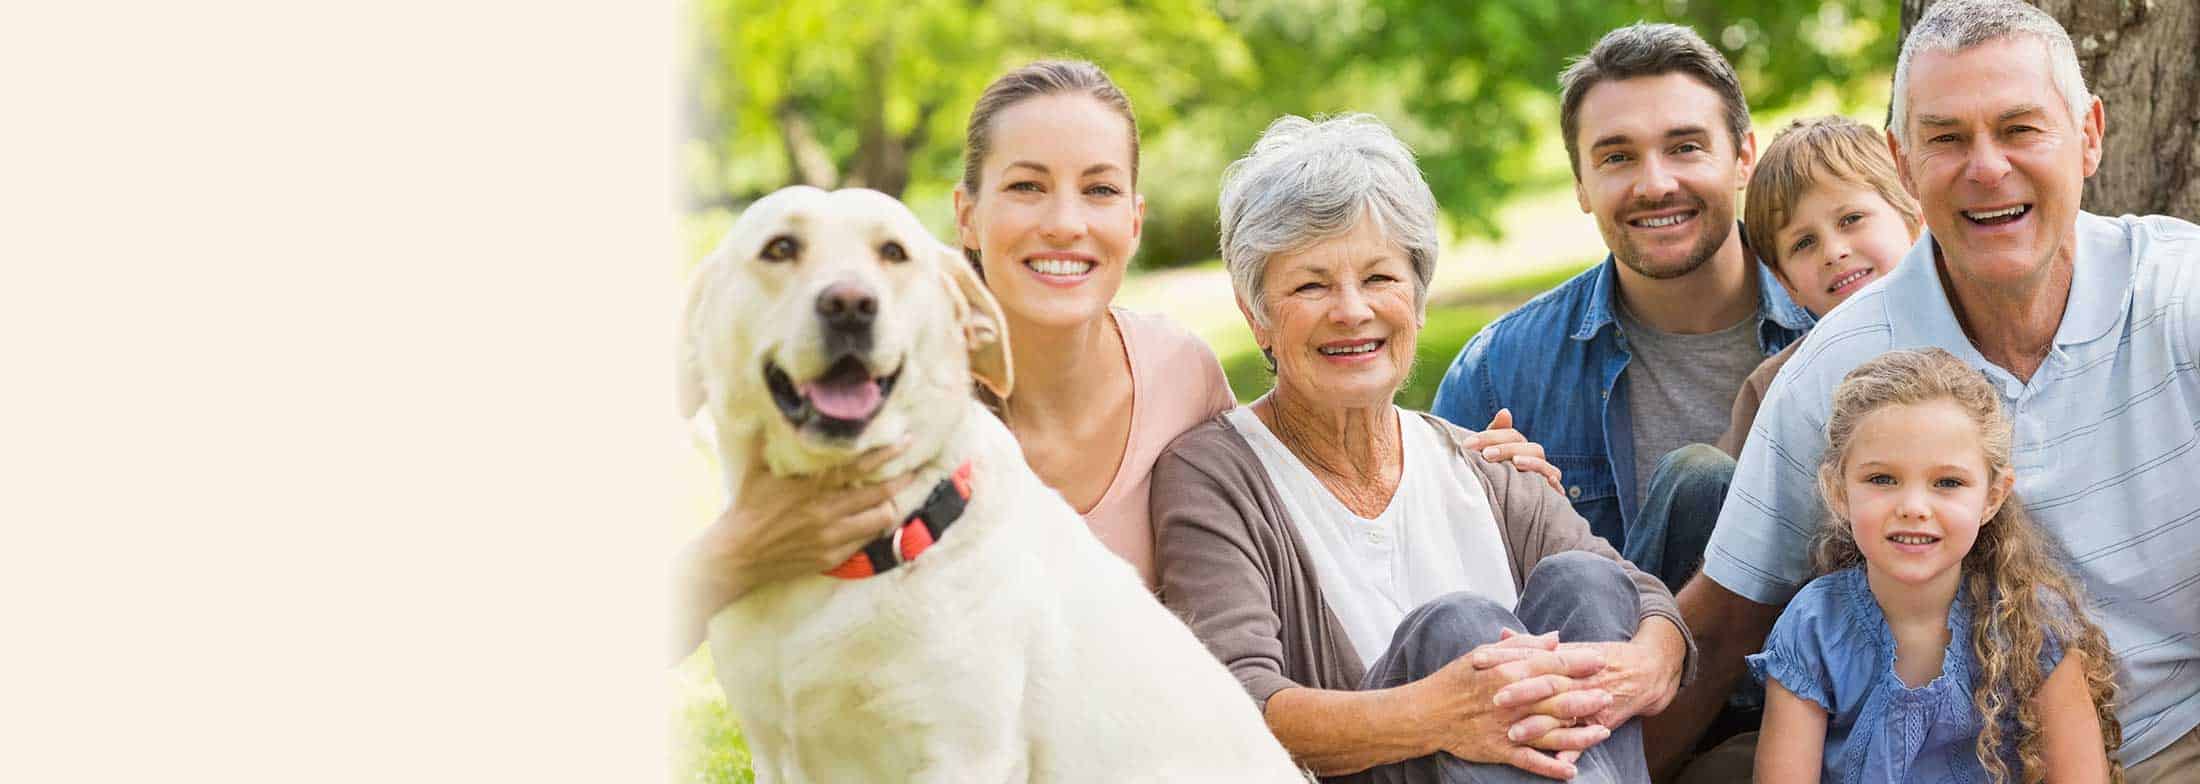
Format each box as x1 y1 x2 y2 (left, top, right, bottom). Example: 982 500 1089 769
1430 251 1815 548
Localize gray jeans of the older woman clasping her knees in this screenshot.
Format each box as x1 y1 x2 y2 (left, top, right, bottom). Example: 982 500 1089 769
1327 553 1650 784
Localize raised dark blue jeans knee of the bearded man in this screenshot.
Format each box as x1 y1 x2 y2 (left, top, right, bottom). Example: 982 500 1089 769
1613 443 1734 595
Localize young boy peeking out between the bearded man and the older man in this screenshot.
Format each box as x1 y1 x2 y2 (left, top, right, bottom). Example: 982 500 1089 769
1718 115 1918 458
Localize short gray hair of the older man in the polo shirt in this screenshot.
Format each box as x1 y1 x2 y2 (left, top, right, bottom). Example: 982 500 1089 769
1888 0 2092 148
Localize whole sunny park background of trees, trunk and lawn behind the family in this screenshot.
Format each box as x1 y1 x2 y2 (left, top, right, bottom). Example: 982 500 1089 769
671 0 2200 782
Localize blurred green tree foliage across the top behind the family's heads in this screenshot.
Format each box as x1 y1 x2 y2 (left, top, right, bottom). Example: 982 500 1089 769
684 0 1899 266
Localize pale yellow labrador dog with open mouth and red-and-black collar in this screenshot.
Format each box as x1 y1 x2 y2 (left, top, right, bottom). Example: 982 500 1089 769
682 187 1305 784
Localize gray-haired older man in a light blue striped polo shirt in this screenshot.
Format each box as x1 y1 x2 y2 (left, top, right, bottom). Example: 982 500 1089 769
1652 0 2200 784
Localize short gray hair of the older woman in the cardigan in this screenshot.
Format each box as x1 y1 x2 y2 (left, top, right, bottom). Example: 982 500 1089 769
1221 115 1441 326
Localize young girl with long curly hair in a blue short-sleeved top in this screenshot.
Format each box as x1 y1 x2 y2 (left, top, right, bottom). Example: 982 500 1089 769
1749 348 2123 784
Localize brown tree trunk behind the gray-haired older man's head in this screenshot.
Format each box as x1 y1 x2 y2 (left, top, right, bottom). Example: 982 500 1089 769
1903 0 2200 220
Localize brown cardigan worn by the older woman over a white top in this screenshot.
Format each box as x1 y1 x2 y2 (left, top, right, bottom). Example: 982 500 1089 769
1153 414 1696 711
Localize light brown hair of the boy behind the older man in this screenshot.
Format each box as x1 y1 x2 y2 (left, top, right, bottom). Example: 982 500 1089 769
1742 115 1918 280
